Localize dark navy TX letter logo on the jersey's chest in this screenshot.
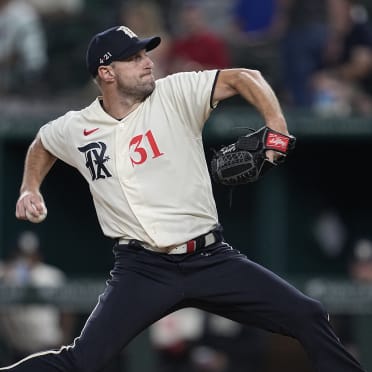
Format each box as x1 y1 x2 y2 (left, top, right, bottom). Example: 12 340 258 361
78 141 112 181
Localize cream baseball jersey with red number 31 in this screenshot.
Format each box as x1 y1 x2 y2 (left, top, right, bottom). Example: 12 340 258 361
40 70 218 250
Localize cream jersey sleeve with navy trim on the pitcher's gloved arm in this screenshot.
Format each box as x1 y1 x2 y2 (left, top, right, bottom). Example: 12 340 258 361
161 70 218 134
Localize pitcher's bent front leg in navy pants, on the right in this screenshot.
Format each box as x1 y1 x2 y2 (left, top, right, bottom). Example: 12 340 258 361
188 248 362 372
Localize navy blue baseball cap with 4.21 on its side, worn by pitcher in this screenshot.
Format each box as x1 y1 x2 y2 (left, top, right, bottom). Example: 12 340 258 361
86 26 161 77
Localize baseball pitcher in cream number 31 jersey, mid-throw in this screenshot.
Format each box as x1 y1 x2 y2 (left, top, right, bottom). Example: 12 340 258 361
0 26 363 372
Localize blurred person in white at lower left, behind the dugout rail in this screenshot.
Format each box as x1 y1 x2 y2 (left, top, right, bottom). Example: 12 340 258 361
0 231 72 362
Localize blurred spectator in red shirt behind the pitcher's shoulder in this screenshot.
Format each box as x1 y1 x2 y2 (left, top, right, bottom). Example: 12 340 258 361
169 0 231 73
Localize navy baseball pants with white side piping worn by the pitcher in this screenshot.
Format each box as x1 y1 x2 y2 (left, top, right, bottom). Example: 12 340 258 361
0 242 363 372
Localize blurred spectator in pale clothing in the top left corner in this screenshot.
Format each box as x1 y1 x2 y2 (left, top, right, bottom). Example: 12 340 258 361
0 0 48 95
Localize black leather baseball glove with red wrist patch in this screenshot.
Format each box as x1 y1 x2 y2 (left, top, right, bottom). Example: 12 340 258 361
211 126 296 186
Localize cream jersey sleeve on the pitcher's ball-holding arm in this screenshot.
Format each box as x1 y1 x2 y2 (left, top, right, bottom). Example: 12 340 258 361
39 113 75 166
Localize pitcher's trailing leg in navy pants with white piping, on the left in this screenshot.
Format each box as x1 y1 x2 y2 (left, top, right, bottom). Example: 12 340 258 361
0 247 183 372
